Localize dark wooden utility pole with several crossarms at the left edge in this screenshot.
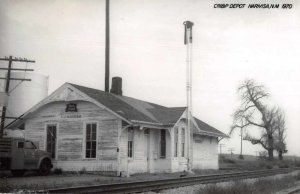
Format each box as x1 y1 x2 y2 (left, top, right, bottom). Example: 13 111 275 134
0 56 35 137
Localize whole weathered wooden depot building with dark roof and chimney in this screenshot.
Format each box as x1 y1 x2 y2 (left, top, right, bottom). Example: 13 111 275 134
9 78 227 175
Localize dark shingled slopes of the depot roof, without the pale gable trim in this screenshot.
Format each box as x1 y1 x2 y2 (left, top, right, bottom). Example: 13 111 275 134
69 83 226 136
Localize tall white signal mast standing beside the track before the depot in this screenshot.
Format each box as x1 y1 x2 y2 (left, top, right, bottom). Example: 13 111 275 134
183 21 194 170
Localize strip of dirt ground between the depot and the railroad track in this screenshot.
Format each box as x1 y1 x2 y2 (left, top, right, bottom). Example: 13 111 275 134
0 170 224 193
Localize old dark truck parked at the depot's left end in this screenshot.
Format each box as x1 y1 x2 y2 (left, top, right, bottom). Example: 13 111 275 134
0 138 53 176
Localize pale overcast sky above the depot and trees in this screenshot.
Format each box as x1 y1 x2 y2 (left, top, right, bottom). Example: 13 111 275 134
0 0 300 156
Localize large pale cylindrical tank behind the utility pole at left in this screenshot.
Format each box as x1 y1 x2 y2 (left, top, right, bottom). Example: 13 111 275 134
5 72 48 124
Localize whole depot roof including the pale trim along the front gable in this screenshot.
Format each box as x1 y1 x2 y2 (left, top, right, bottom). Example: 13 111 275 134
9 83 227 137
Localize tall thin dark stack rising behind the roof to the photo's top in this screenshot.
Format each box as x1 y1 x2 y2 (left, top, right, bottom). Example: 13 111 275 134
105 0 109 92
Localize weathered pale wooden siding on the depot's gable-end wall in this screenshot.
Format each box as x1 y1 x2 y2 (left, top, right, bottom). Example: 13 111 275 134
25 101 120 167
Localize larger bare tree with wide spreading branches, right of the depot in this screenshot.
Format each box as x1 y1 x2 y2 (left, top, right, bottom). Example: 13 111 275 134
229 80 278 160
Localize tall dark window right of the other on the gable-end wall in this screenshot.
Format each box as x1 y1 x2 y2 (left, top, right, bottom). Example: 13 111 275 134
85 123 97 158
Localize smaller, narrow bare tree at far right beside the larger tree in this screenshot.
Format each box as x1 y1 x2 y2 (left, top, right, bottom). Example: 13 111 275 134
273 110 287 160
